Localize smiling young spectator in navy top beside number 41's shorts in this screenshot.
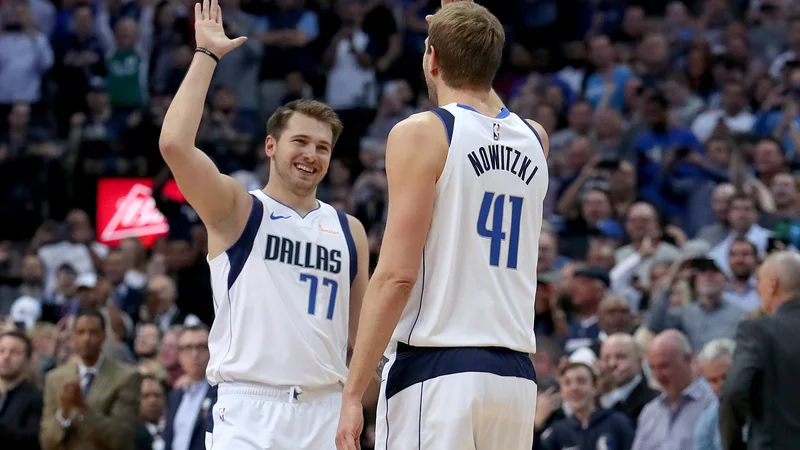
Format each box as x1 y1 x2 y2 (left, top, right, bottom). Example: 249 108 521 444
541 362 634 450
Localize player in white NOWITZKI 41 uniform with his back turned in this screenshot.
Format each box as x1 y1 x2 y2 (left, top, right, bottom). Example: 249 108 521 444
336 2 548 450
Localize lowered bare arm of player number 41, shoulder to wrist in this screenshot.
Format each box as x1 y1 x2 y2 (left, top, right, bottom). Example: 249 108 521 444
344 113 447 402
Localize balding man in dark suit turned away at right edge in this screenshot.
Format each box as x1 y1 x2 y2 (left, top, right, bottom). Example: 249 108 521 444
719 252 800 450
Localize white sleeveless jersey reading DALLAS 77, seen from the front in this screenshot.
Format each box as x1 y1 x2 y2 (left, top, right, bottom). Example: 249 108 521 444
206 190 358 387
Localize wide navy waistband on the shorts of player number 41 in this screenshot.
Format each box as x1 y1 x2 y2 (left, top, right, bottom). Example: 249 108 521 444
385 342 536 400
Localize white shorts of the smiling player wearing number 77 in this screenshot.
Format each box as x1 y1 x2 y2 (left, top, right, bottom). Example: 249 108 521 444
206 383 342 450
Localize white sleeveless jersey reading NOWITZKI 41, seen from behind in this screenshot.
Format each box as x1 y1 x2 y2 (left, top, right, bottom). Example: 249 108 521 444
387 104 548 354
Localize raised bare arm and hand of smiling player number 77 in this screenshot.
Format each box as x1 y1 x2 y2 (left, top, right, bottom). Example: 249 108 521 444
159 0 252 248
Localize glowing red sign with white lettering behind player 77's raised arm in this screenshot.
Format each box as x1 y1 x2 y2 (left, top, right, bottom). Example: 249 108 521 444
97 178 185 248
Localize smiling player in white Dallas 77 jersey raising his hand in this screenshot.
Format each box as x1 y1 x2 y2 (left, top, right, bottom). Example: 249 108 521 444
160 0 368 450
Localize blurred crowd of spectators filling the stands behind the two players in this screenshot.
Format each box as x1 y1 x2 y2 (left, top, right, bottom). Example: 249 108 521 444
0 0 800 450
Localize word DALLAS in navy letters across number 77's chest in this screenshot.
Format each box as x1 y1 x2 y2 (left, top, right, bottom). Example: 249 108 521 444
265 234 342 273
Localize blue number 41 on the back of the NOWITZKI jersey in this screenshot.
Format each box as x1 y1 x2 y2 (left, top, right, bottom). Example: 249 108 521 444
478 192 522 269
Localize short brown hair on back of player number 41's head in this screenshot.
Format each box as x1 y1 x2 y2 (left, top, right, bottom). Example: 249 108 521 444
425 2 506 89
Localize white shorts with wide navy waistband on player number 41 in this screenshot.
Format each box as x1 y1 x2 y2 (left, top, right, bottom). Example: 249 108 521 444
375 344 537 450
